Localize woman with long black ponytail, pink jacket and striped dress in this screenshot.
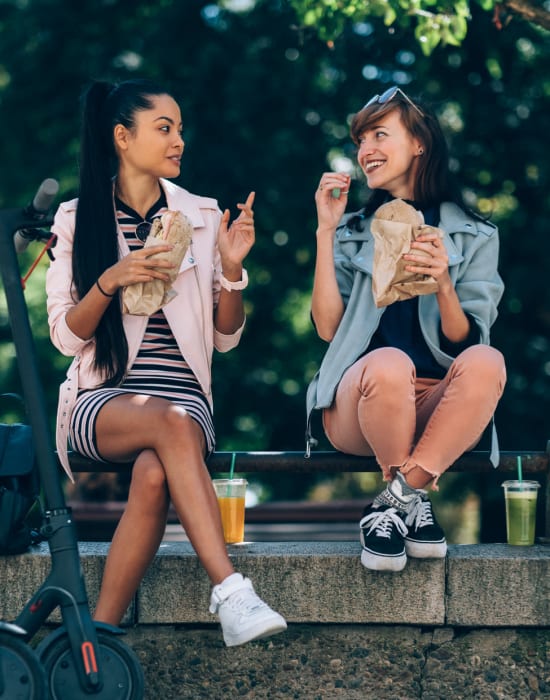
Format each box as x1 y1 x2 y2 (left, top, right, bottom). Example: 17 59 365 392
47 80 286 646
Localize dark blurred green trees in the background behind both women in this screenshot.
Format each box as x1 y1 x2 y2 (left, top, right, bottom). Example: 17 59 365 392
0 0 550 541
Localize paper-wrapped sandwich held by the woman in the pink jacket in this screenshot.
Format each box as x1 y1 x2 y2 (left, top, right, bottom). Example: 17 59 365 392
122 211 193 316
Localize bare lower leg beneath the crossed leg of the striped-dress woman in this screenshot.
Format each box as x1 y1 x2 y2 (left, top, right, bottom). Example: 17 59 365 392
94 450 170 625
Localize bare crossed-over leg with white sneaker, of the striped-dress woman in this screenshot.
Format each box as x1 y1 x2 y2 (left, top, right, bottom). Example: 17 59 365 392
92 394 286 646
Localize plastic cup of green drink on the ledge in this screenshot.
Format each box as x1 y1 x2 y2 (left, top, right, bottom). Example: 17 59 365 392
502 481 540 545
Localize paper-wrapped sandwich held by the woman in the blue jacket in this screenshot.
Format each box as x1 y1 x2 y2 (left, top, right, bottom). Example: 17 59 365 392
371 199 443 307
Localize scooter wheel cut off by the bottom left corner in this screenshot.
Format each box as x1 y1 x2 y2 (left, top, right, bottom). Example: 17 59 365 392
0 633 48 700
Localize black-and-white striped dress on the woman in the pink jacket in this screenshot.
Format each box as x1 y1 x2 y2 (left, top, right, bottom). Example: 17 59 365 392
69 195 215 461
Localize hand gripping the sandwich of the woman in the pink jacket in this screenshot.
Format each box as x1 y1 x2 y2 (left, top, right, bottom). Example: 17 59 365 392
100 243 174 294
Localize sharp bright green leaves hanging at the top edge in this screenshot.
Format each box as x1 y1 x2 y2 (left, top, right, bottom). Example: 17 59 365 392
290 0 502 56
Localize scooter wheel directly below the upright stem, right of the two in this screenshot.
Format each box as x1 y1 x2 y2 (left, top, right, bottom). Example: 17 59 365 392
37 628 144 700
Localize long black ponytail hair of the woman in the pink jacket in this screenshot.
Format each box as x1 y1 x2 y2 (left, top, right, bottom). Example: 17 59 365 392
72 80 169 386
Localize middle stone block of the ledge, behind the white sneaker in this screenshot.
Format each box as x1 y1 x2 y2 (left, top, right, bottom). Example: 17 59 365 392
139 542 445 625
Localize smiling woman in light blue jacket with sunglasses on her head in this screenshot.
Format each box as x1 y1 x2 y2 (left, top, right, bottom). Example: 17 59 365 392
308 87 506 571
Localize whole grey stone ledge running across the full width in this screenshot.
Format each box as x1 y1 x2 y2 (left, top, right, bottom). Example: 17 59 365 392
0 542 550 628
